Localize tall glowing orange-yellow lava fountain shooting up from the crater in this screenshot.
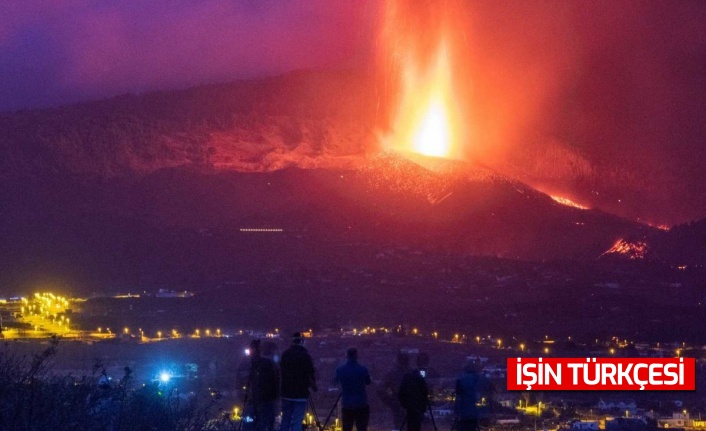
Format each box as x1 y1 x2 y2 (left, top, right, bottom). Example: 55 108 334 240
381 1 467 159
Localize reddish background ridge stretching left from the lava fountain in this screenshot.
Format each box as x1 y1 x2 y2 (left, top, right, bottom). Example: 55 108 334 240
0 72 374 177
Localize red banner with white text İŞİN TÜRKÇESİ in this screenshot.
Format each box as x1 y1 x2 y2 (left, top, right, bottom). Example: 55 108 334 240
507 358 696 391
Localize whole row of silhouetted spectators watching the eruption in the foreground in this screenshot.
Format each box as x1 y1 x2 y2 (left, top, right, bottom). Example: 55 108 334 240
243 333 491 431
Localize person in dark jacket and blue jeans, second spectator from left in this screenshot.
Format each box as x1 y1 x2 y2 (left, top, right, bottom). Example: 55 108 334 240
280 332 317 431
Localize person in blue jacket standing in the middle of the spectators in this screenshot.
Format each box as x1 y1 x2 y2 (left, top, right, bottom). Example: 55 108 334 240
336 347 370 431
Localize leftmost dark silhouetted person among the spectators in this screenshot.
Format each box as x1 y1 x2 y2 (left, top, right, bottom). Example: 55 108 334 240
244 340 279 431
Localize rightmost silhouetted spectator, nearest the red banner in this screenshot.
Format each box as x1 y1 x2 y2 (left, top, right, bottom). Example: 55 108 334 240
454 362 492 431
